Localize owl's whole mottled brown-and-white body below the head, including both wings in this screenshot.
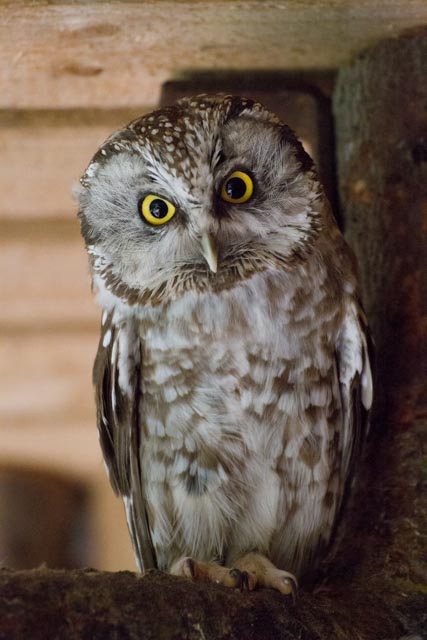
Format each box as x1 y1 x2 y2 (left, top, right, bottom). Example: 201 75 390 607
95 251 371 572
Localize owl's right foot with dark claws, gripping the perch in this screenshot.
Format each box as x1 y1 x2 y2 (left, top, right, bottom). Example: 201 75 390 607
234 553 298 602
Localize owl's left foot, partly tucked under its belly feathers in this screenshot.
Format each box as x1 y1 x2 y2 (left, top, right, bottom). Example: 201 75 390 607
171 558 256 591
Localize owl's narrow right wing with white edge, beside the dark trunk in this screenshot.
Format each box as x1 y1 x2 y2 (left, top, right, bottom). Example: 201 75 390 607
336 302 373 481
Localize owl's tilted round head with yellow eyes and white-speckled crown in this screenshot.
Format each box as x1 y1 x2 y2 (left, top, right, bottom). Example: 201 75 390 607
79 96 324 304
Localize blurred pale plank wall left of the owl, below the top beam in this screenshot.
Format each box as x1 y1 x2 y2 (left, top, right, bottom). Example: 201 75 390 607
0 109 139 569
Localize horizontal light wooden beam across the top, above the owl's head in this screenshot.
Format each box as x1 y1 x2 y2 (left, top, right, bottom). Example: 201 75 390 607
0 0 427 108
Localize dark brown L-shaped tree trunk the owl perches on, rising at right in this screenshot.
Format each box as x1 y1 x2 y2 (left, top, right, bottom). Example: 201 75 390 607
0 31 427 640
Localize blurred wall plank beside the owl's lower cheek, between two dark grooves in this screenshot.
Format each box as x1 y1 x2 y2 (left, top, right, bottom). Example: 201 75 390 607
0 220 100 333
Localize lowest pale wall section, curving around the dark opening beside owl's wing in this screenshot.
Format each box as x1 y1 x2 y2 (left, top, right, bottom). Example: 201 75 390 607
0 332 135 571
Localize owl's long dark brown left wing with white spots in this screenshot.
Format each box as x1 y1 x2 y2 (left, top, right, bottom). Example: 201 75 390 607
93 313 156 571
